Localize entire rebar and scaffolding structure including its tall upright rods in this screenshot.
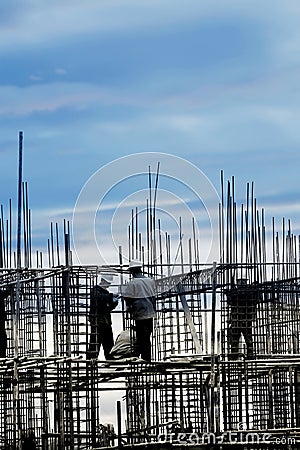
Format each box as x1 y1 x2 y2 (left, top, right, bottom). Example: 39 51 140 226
0 135 300 450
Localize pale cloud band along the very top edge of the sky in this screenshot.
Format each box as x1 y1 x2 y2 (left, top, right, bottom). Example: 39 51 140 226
0 0 300 58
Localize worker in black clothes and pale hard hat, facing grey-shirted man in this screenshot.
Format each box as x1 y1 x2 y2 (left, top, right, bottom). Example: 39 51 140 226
87 274 118 359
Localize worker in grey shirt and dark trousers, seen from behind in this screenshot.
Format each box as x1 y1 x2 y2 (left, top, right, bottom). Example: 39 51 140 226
122 260 156 361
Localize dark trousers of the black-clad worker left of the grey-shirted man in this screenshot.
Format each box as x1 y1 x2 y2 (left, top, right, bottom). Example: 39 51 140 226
87 322 114 359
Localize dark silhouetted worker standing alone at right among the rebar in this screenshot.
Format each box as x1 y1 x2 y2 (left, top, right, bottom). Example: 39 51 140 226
226 278 259 359
